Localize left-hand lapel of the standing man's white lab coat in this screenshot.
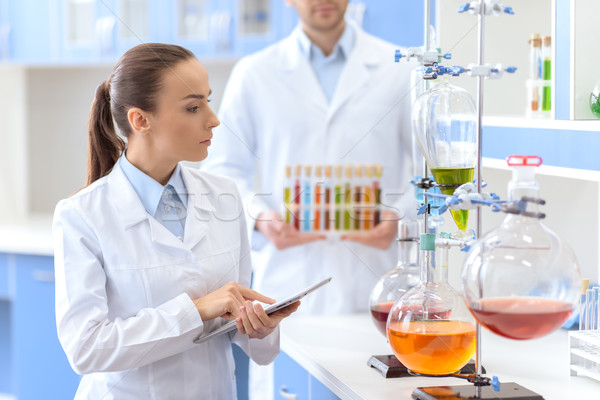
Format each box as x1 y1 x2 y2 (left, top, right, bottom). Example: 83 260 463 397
280 32 329 110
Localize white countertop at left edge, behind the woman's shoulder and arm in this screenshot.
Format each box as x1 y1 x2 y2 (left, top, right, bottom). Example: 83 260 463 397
0 214 54 256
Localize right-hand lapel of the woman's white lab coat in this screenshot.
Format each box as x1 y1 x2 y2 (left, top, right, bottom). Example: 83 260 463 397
181 167 216 250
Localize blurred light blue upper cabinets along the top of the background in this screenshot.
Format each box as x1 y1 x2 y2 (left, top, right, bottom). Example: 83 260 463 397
0 0 423 63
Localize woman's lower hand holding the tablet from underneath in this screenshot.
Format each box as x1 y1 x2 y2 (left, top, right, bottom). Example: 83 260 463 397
235 301 300 339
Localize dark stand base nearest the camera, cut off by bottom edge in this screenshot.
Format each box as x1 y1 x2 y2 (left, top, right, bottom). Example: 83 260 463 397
412 382 544 400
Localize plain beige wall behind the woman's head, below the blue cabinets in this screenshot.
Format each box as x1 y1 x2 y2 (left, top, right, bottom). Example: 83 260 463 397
0 60 236 223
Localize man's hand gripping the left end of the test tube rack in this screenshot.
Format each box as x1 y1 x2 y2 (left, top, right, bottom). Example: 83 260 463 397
256 211 327 250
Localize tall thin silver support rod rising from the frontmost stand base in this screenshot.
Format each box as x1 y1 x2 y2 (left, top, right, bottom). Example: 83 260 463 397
475 0 485 388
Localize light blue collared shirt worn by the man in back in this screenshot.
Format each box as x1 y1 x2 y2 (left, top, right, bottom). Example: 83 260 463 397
298 22 355 102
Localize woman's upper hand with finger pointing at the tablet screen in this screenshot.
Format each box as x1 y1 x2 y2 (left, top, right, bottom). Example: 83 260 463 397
194 282 275 321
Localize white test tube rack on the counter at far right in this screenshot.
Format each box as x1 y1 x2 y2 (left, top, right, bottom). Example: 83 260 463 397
569 330 600 382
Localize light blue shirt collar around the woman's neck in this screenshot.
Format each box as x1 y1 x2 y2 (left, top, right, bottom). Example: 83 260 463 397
119 152 187 216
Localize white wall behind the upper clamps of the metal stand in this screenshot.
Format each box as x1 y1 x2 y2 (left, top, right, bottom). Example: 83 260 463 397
437 0 552 116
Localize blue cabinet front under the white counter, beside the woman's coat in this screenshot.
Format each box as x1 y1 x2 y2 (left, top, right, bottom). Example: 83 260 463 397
273 352 339 400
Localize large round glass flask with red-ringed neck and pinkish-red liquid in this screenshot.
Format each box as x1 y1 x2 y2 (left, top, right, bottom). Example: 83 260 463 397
462 156 581 340
